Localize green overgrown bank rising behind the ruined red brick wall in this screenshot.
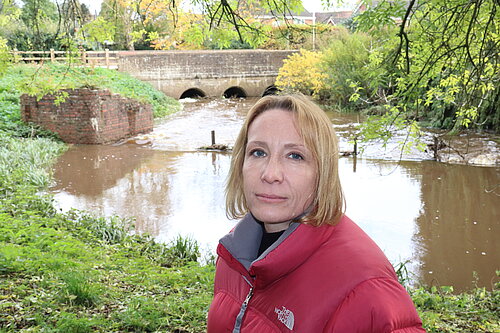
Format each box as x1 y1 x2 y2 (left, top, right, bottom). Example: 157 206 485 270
0 64 181 137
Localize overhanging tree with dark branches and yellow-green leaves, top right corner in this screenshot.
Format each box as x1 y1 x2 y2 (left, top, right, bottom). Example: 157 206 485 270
342 0 500 132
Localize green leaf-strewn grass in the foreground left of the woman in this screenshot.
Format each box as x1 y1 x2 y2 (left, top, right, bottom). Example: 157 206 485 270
0 194 214 332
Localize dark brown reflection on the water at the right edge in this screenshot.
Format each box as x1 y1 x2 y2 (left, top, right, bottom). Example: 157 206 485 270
416 161 500 289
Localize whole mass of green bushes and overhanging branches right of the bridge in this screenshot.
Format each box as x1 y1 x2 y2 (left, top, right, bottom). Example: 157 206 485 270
278 0 500 139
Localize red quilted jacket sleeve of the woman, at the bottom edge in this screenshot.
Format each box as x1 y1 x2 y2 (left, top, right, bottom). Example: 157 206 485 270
324 278 425 333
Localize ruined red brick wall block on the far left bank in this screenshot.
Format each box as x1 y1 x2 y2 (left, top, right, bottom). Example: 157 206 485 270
21 89 153 144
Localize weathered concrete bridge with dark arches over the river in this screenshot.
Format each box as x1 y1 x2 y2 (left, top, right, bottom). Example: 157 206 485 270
118 50 297 99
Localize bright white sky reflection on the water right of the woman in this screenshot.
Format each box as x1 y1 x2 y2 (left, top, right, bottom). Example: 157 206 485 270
339 158 420 263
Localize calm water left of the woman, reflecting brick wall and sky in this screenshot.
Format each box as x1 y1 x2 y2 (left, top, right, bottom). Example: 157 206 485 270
51 144 234 248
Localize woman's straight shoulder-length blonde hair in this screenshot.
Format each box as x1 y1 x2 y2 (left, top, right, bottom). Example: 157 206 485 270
226 94 344 226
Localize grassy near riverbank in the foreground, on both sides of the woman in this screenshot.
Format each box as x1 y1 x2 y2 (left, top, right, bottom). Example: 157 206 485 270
0 134 500 332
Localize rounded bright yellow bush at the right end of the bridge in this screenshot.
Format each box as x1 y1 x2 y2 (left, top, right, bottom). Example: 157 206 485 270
276 49 327 96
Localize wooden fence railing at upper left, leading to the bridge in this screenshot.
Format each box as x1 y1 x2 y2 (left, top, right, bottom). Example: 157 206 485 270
11 49 118 68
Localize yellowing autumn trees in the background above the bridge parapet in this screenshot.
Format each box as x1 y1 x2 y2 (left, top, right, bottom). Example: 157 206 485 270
94 0 302 49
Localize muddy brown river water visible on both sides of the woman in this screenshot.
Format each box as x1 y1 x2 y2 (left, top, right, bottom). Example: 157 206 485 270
50 99 500 290
